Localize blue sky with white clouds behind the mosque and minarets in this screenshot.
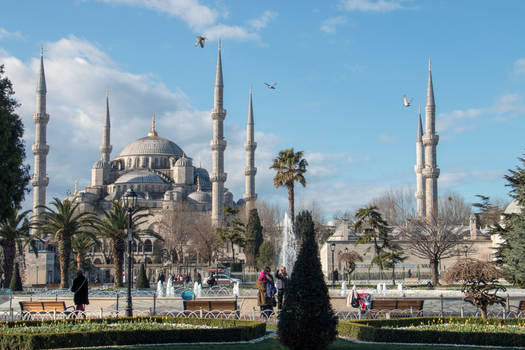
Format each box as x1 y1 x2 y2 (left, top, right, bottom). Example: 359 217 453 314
0 0 525 217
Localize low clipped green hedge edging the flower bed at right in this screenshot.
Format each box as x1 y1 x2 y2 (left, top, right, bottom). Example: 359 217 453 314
337 317 525 346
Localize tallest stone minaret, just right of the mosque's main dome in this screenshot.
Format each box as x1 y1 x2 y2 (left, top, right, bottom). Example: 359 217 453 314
210 40 226 227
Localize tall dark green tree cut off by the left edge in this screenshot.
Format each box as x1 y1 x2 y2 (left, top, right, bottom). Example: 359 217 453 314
0 65 29 220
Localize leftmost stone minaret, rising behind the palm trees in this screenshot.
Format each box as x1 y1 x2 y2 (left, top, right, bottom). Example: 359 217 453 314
31 47 49 215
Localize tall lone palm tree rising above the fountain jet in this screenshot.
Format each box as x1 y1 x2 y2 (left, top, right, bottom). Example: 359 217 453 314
270 148 308 224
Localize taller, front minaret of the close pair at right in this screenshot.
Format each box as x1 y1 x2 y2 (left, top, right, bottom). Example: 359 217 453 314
423 60 439 220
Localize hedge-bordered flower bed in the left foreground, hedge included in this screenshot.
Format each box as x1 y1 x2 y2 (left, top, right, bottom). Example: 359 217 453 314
0 317 266 349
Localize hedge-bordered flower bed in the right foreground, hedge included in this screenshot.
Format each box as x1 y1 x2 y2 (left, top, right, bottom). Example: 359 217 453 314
338 317 525 346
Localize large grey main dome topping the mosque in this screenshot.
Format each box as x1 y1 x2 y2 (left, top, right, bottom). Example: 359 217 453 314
119 134 183 158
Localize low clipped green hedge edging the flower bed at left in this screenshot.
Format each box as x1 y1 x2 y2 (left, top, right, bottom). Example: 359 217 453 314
0 317 266 350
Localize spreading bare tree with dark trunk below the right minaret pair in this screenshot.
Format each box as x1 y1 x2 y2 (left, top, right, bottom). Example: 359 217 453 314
399 218 461 286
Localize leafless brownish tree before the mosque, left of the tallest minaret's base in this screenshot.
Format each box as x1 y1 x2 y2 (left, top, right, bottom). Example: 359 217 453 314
158 203 196 263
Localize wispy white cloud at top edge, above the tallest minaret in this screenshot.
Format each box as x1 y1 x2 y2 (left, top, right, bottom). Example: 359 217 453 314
99 0 277 40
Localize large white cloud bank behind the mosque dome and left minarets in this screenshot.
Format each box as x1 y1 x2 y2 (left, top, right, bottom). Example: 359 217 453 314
0 36 281 208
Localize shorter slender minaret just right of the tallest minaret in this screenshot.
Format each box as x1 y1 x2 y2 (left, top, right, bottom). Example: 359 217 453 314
244 86 257 215
